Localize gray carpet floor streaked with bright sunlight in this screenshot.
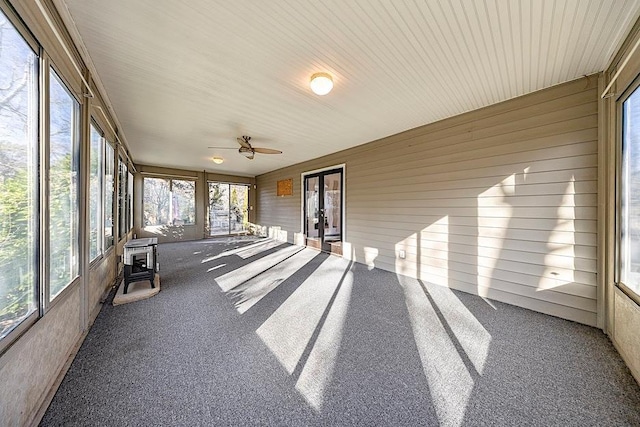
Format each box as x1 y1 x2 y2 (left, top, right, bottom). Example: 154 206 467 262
41 238 640 426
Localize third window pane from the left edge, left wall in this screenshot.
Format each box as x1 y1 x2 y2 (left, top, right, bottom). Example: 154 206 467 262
89 124 104 261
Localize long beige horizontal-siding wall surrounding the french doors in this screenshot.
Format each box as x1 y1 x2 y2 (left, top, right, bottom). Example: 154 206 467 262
257 76 598 325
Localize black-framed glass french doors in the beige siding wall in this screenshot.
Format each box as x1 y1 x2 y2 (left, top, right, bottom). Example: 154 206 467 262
304 168 344 254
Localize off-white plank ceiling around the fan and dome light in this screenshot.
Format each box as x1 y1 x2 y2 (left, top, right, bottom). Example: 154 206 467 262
54 0 640 176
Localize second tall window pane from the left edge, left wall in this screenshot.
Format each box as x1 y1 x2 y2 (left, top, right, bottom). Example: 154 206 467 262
48 70 80 299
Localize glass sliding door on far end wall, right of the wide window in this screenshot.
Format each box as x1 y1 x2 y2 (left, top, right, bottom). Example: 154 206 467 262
209 182 249 236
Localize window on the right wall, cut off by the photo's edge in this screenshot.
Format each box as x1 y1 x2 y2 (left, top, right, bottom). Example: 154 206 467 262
620 85 640 295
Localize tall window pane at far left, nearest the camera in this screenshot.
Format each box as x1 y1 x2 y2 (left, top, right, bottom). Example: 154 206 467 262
0 11 38 338
